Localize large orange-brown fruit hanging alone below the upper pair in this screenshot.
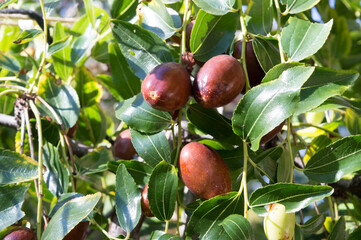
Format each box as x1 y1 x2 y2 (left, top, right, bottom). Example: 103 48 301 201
179 142 232 199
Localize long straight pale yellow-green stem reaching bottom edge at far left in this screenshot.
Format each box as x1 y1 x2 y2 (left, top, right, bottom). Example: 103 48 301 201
29 100 43 239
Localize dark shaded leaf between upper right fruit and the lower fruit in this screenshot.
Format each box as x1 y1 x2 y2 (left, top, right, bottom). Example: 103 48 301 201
187 103 241 145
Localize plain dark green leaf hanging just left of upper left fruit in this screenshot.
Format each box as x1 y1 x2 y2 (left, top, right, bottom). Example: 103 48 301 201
108 43 141 99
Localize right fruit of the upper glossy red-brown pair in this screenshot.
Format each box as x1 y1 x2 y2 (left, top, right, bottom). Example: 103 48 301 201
193 55 246 108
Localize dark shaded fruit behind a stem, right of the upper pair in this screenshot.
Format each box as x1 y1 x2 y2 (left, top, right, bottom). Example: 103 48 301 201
233 39 265 87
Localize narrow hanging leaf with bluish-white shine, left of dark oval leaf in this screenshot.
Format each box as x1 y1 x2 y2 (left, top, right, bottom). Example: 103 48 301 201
115 164 142 233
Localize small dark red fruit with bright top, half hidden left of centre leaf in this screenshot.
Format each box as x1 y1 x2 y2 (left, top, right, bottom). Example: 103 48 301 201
113 128 137 160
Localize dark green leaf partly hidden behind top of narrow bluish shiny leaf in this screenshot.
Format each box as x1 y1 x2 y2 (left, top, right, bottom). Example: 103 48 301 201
107 160 153 186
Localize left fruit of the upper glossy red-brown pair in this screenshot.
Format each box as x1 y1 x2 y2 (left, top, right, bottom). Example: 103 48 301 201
142 62 191 112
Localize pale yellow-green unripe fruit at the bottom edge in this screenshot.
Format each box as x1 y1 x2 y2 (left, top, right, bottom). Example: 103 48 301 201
263 203 295 240
